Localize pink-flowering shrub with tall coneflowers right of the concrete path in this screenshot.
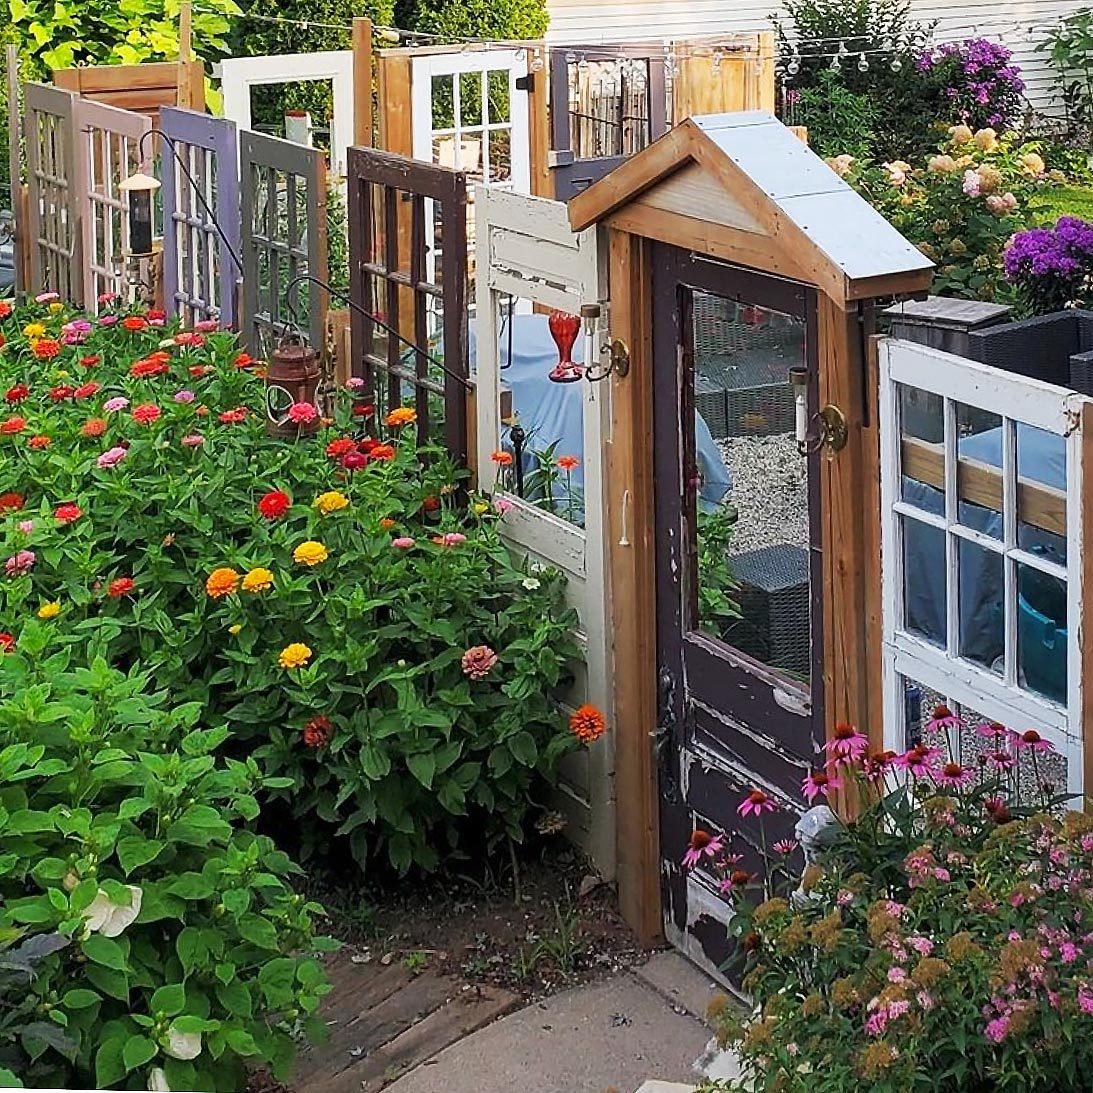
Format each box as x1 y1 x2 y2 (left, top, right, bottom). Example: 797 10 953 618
687 707 1093 1093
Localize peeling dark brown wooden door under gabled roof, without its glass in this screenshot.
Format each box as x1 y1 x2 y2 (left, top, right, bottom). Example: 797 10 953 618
651 244 824 965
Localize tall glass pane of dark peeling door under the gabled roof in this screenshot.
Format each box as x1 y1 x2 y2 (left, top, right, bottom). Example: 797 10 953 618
684 292 811 683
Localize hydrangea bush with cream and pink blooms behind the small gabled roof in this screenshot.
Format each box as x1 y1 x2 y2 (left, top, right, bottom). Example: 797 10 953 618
831 126 1065 299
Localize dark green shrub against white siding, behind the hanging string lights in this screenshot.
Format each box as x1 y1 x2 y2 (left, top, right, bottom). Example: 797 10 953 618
772 0 945 160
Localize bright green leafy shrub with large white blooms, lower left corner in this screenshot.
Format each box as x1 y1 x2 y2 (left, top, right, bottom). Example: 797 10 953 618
0 638 327 1091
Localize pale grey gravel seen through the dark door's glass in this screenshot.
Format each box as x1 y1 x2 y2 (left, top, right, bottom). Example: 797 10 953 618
717 435 809 554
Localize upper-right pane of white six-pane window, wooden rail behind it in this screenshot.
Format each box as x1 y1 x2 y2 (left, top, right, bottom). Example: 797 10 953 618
1018 425 1067 564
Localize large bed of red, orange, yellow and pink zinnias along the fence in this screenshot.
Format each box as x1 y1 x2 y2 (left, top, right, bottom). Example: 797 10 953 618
0 302 587 871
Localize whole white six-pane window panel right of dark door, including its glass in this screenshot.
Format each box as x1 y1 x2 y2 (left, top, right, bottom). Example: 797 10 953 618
879 339 1093 794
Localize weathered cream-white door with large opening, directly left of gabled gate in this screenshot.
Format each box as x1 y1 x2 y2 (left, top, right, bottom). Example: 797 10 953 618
474 187 615 877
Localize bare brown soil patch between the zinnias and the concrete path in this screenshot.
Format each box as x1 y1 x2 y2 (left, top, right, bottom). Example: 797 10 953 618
315 847 647 1000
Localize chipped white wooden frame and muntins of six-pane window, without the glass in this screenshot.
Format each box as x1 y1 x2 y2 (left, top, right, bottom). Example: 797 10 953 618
878 338 1089 794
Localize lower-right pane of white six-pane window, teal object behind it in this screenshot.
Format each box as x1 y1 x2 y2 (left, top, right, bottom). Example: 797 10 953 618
1018 565 1067 703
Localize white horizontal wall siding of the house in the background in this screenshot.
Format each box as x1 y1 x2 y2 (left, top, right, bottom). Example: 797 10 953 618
547 0 1089 109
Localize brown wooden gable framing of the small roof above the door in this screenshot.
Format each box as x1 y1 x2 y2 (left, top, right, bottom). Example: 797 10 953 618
569 116 933 309
